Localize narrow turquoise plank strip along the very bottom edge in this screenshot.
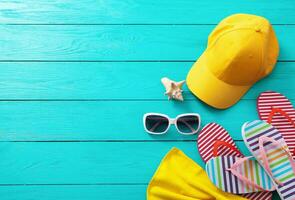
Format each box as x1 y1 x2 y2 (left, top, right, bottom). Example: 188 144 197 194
0 185 147 200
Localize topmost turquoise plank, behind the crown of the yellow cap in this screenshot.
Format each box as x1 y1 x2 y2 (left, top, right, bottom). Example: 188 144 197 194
0 0 295 24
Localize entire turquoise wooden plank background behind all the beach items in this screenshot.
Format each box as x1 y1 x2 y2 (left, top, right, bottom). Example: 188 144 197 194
0 0 295 200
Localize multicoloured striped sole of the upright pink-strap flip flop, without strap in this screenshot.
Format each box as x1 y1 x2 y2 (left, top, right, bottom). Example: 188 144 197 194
242 120 295 200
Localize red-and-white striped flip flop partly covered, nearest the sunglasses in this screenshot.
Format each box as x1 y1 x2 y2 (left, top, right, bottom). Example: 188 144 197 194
197 123 272 200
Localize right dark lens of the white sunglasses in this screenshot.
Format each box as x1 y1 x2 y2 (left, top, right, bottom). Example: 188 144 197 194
176 115 200 134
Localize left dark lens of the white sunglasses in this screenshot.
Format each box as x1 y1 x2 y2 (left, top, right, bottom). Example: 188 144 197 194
145 115 169 134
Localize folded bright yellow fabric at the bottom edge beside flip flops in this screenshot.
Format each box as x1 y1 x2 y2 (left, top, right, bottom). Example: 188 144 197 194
147 148 244 200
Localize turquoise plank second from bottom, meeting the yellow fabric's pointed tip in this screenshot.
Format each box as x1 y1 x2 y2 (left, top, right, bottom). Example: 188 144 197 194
0 141 248 185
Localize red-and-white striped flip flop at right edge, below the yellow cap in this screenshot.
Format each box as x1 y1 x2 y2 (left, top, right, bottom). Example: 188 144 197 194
257 91 295 158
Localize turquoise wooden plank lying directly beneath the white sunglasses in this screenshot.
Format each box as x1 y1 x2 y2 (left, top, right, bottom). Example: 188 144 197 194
0 100 294 141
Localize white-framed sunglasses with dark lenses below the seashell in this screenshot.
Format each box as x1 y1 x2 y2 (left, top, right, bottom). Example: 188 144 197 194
143 113 201 135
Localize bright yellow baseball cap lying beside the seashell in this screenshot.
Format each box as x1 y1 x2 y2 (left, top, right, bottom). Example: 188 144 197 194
186 14 279 109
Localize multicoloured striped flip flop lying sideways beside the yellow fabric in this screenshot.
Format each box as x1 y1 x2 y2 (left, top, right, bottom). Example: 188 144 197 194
206 156 275 194
